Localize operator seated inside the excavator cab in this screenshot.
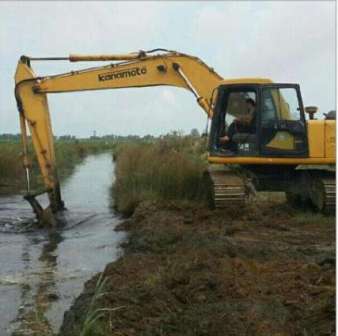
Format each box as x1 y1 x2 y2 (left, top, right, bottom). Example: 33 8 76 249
219 98 256 156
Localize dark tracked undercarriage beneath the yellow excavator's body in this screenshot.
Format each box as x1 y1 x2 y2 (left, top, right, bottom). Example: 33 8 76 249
204 166 336 214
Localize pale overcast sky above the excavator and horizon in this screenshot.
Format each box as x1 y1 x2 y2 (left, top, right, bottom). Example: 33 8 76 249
0 1 336 136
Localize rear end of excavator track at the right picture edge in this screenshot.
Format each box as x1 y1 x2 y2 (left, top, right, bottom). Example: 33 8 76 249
311 176 336 213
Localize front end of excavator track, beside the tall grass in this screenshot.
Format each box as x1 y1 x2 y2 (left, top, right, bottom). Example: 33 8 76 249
206 170 247 209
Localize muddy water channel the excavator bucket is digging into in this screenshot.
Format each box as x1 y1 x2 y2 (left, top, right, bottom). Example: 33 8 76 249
0 154 123 336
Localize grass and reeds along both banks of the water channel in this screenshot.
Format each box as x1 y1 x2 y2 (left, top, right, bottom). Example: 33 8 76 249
0 130 205 197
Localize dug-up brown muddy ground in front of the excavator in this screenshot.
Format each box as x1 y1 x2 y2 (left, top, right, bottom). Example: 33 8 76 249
60 195 335 336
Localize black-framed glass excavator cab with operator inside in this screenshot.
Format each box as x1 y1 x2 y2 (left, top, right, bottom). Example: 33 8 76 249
210 83 308 157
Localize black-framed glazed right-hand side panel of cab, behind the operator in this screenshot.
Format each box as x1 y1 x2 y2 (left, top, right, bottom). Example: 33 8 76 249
258 84 308 157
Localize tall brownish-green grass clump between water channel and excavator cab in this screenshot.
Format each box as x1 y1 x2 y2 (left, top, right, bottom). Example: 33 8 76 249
113 134 206 214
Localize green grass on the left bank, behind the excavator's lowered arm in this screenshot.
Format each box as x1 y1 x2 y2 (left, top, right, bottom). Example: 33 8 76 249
0 141 115 194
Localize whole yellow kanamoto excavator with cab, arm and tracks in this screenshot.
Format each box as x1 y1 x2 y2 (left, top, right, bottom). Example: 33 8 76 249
15 49 336 218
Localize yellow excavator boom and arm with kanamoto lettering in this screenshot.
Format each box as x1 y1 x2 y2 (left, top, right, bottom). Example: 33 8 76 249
15 49 222 217
